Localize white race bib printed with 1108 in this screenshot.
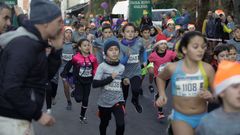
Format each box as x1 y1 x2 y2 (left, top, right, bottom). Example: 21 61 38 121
176 76 204 97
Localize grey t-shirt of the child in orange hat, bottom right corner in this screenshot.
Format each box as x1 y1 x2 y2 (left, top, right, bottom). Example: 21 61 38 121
196 107 240 135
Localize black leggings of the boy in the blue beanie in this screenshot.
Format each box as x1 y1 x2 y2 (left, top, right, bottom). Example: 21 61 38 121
98 102 125 135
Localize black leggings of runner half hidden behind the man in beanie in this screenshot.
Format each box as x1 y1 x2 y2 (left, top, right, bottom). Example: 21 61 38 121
46 82 58 109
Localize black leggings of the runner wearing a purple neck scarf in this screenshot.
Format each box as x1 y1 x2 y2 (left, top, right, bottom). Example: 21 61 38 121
122 76 141 102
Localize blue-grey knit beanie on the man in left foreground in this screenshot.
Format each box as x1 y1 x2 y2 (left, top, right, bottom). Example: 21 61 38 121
30 0 61 24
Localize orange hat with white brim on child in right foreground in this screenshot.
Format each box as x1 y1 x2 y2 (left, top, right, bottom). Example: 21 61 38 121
213 61 240 96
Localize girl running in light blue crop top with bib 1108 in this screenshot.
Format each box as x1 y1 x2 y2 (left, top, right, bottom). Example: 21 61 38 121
156 31 214 135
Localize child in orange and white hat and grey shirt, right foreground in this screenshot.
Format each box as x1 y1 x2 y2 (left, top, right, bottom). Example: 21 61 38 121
196 61 240 135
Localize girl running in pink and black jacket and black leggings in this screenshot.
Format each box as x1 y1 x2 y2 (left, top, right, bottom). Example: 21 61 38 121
61 39 98 124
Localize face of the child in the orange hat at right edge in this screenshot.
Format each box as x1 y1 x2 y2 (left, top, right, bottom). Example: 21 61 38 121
220 84 240 112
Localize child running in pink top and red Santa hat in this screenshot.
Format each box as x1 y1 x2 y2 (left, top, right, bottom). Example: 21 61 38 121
148 39 177 119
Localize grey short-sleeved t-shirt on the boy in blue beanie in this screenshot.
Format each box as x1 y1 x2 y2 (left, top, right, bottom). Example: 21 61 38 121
94 62 125 108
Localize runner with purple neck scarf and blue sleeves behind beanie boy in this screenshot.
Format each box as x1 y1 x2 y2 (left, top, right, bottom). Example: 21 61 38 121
120 23 147 113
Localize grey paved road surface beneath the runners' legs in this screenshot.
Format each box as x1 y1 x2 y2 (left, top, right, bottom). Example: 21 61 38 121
34 78 171 135
